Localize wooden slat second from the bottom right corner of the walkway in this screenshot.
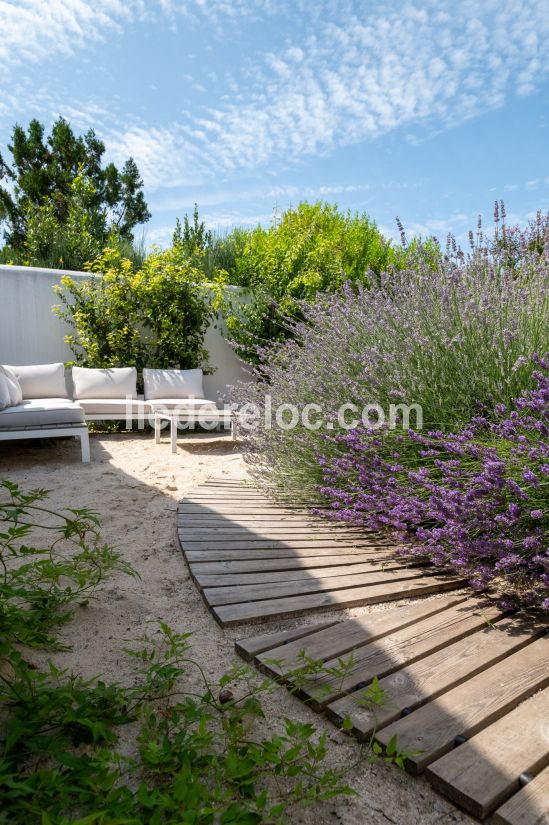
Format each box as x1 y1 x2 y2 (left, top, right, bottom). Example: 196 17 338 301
426 690 549 819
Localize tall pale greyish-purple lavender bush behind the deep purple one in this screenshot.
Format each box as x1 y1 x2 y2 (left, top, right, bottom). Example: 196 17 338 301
236 209 549 499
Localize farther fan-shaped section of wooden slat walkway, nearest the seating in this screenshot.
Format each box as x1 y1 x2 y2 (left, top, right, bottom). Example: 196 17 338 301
177 480 463 625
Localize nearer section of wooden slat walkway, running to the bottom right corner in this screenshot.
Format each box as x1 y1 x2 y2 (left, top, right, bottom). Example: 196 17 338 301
235 594 549 825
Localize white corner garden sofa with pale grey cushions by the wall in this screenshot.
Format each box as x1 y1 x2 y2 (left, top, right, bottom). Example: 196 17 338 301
0 363 223 463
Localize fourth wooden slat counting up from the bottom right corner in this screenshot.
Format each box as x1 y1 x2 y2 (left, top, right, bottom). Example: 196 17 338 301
326 611 543 740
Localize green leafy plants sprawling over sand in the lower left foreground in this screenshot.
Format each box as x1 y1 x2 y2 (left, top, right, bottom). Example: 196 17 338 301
0 482 408 825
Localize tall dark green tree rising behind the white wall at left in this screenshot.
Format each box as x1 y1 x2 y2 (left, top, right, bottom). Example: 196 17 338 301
0 117 150 253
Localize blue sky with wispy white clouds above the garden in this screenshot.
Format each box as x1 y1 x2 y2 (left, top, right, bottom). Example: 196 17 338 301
0 0 549 244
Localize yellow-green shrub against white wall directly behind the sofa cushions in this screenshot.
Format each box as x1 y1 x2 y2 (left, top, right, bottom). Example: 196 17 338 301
52 248 213 371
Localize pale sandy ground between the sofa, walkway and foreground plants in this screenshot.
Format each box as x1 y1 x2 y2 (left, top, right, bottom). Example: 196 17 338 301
0 433 473 825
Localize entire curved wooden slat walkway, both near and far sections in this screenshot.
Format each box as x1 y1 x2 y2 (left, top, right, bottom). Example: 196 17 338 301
178 480 549 825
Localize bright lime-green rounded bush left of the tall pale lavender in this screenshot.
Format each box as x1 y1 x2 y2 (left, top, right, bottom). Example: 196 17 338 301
218 202 399 361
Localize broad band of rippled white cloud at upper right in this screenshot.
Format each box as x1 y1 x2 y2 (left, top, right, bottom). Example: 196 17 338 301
165 0 549 172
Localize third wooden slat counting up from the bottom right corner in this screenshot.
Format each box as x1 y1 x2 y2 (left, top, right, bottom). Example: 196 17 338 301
376 637 549 773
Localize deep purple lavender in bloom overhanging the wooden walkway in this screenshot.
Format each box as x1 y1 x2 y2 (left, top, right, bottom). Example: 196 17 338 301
319 354 549 610
